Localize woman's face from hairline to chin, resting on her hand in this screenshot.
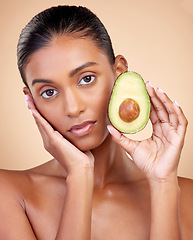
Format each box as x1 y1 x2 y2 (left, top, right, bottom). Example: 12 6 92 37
25 36 116 151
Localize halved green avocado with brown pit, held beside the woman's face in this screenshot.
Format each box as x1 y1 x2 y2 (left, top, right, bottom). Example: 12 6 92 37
108 72 151 133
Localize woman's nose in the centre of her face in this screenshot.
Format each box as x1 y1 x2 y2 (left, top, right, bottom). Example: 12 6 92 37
64 89 86 118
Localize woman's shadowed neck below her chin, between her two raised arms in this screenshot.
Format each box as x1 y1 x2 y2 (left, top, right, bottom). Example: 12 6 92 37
92 134 144 188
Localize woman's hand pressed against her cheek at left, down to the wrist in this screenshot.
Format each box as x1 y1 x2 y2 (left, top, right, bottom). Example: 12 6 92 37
25 94 94 174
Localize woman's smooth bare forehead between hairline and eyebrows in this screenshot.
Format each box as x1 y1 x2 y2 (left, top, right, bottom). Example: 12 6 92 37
25 37 110 83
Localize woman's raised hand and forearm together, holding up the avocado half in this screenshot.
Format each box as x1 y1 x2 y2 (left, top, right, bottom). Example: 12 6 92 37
108 81 187 240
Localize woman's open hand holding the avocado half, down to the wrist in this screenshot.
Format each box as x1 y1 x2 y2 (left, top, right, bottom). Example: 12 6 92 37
108 82 187 181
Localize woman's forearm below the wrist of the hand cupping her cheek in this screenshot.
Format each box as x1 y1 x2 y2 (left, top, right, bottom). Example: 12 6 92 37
56 169 93 240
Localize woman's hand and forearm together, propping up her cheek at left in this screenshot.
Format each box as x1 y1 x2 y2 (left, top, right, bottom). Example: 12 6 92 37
27 96 94 240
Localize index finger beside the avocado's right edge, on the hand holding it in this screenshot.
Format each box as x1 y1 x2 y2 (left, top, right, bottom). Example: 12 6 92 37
146 82 169 123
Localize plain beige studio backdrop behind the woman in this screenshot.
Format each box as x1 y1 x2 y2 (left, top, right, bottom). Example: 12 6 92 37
0 0 193 178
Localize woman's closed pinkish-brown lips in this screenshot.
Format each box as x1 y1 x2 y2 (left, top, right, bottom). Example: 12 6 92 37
69 121 96 137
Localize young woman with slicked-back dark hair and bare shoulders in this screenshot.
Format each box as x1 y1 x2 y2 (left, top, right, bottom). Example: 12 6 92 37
0 6 193 240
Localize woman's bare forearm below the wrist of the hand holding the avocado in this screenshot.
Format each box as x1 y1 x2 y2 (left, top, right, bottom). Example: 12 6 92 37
150 178 182 240
